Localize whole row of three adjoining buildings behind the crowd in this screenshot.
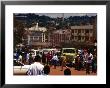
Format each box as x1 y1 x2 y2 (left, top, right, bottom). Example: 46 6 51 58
24 24 97 48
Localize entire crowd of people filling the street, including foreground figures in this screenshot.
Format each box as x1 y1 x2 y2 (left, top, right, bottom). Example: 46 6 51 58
14 49 97 75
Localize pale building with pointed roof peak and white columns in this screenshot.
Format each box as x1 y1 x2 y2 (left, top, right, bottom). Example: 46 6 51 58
24 23 48 48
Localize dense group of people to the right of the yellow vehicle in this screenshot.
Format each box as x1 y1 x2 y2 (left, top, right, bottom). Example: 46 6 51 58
75 50 97 74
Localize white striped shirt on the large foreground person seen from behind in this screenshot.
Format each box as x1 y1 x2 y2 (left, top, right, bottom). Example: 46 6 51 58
27 62 44 75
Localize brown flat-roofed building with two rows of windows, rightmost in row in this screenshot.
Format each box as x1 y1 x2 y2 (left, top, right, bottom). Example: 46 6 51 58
71 25 96 43
